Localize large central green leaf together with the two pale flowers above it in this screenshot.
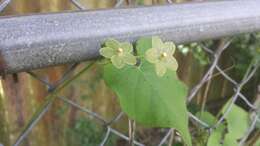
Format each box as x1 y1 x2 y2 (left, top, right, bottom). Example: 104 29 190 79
100 37 191 146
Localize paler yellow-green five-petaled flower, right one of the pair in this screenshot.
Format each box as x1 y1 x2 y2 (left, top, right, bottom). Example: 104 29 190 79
145 37 178 76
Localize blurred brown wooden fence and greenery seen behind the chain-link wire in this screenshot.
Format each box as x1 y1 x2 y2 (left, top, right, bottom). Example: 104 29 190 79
0 0 260 146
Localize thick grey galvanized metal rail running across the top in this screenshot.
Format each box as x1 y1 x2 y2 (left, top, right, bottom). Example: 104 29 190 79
0 0 260 74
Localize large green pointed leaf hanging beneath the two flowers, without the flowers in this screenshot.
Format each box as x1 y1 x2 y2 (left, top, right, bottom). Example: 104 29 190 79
104 38 192 146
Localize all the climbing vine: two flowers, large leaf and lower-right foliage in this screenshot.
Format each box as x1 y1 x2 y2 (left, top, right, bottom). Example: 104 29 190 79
96 37 257 146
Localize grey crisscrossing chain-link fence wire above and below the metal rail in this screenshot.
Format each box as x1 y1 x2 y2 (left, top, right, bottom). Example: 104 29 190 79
0 0 260 146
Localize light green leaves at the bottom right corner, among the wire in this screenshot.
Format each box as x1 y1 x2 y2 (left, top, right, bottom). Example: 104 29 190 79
193 102 250 146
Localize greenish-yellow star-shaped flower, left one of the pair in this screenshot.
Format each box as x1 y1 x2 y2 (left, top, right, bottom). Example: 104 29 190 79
99 39 136 69
